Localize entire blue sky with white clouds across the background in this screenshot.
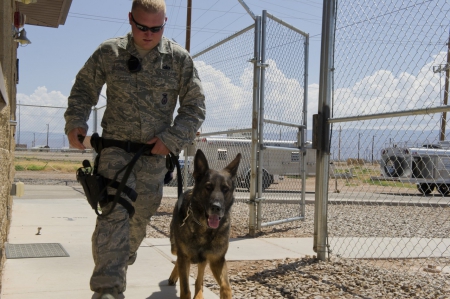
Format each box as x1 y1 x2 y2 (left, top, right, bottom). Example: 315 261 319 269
17 0 450 155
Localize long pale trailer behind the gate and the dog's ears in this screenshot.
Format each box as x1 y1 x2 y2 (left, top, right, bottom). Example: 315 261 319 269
176 137 316 189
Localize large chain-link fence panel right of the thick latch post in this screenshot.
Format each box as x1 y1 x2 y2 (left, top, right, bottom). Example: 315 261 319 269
316 0 450 287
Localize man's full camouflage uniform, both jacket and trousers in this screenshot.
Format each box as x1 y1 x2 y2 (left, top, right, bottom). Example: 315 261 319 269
64 33 205 292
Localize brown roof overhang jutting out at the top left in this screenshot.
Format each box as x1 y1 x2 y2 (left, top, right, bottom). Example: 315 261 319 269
16 0 72 28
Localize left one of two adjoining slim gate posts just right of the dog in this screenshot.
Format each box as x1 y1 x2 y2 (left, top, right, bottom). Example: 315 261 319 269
248 16 261 237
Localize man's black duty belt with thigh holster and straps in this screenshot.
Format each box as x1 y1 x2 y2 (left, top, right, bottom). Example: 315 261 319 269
77 133 182 218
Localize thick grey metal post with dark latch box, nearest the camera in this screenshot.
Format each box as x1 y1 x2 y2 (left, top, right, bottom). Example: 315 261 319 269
313 0 336 261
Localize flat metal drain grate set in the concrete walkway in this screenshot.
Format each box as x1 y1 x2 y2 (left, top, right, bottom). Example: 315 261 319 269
5 243 70 259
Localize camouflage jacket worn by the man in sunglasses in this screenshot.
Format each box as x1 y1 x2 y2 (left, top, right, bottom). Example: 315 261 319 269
64 33 205 154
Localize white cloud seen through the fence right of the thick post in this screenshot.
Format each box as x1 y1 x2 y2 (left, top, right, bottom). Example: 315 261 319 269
334 52 446 131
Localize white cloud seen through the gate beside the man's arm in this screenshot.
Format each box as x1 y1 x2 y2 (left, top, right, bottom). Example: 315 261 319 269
196 60 317 136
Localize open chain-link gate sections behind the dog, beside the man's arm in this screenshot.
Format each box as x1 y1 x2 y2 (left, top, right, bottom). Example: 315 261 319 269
190 11 314 236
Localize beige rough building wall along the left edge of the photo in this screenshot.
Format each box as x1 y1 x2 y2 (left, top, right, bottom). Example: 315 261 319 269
0 0 17 288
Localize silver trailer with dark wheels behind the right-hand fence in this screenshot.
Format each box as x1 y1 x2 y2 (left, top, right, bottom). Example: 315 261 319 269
378 142 450 195
